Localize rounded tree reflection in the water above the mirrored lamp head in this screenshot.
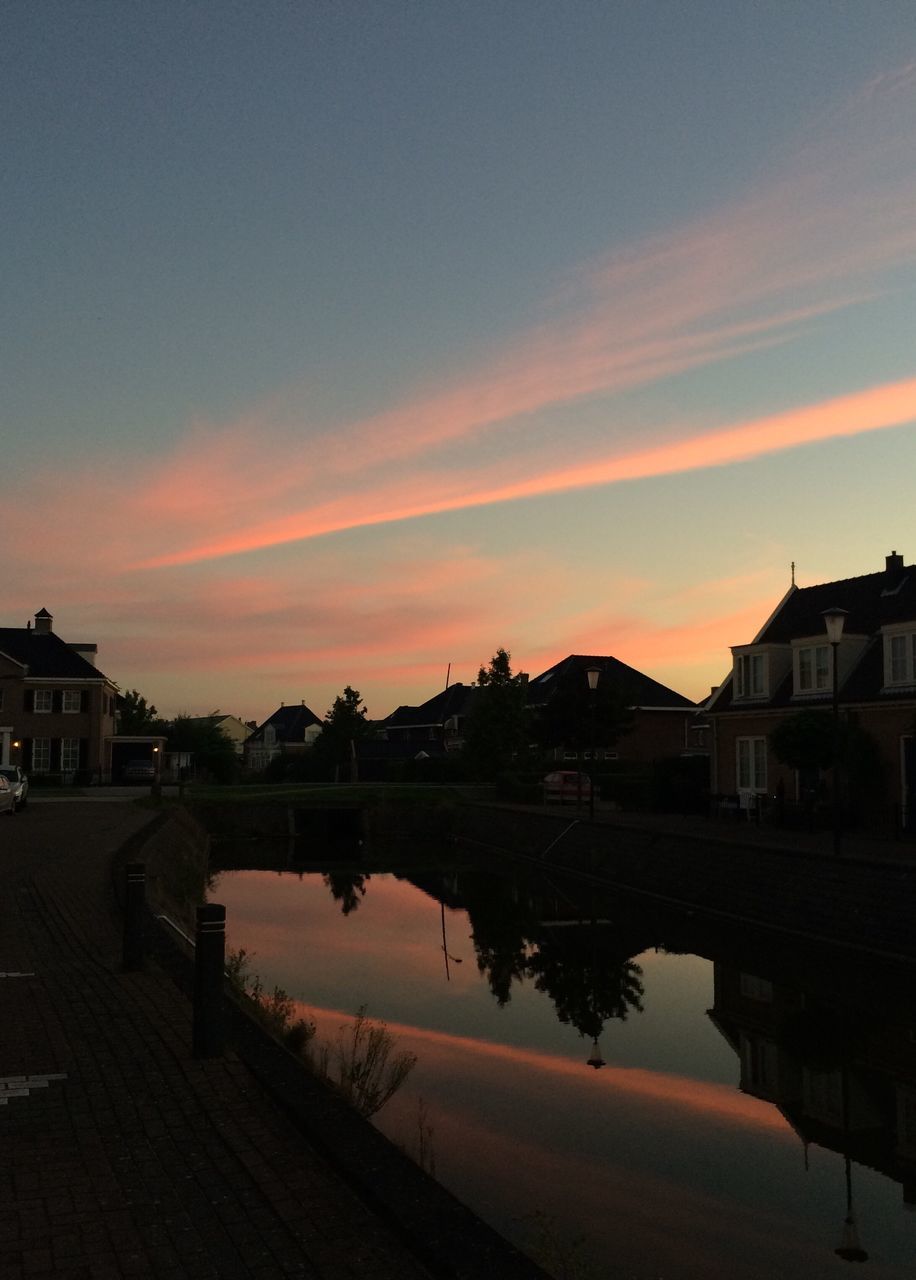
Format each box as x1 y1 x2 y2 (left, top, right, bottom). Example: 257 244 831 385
528 929 644 1039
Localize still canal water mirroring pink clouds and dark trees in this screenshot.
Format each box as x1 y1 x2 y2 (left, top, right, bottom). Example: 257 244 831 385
210 849 916 1280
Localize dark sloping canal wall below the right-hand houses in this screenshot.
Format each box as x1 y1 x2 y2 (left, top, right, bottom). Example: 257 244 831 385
457 804 916 961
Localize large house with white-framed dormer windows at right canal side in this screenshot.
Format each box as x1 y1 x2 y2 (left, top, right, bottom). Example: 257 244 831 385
707 552 916 827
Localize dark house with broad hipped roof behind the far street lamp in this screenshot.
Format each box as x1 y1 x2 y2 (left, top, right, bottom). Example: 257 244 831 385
528 654 709 764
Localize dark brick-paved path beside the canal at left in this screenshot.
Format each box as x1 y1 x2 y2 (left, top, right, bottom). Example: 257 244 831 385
0 803 440 1280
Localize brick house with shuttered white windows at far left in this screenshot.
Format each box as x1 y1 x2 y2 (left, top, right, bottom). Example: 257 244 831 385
0 609 118 781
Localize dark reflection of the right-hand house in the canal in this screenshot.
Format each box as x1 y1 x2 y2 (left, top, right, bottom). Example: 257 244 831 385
710 963 916 1207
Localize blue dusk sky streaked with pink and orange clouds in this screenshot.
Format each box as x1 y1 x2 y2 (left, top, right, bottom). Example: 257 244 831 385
0 0 916 722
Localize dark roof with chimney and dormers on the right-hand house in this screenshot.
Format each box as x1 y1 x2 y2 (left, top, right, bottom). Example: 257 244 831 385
710 552 916 712
